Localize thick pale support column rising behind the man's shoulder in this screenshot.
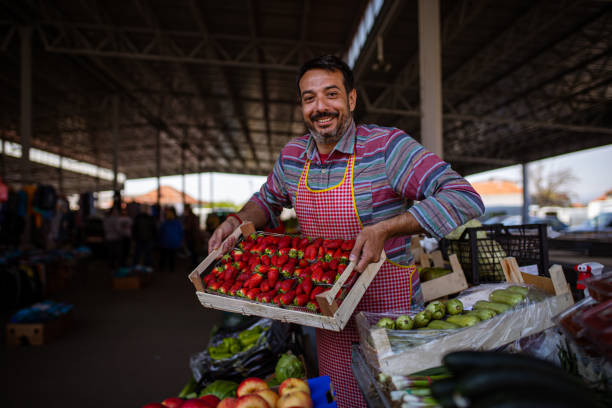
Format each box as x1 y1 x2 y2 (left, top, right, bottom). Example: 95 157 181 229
419 0 444 158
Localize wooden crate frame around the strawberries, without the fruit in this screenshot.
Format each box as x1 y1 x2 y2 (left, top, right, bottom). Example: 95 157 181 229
189 223 386 331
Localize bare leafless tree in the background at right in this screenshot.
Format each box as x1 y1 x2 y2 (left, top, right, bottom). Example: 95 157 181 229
529 163 579 207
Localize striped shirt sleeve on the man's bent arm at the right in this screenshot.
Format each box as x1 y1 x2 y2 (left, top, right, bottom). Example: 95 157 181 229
385 130 484 238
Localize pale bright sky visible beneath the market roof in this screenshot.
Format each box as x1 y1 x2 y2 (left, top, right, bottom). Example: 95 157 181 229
124 144 612 204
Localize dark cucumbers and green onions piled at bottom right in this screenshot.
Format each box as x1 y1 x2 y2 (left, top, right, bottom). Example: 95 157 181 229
377 351 605 408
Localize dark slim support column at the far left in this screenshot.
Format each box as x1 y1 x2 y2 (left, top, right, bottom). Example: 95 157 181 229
19 27 32 184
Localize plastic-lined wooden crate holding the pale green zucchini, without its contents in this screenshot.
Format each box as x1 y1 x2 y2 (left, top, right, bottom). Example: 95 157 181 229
356 258 574 375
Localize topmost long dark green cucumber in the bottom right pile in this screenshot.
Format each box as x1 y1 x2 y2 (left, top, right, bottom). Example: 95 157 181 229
455 367 592 406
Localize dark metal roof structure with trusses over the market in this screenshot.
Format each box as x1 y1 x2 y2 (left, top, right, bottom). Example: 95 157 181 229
0 0 612 192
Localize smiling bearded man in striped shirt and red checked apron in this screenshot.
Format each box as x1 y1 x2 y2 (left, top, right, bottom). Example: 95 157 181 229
209 56 484 407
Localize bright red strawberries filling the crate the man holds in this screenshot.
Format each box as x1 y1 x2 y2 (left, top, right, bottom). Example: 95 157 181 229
202 233 357 312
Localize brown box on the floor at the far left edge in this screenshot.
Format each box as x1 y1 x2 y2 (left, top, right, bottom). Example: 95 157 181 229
6 312 72 346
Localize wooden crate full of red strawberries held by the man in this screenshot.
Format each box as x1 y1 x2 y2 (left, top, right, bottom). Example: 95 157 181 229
189 223 385 331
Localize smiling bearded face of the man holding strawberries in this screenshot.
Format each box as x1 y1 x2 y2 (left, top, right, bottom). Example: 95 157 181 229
299 69 357 151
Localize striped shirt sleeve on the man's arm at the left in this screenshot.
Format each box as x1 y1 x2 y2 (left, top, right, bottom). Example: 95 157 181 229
249 153 291 227
